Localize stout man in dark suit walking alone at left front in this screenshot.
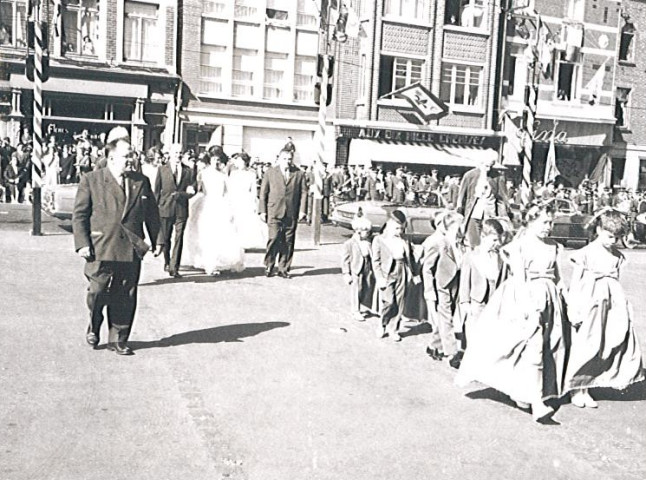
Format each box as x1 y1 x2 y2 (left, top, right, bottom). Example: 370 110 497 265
72 127 159 355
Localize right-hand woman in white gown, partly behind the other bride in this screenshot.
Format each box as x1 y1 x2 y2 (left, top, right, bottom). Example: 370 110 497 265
228 153 267 249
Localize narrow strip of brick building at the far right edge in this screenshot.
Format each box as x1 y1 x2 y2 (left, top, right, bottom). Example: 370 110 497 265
612 0 646 190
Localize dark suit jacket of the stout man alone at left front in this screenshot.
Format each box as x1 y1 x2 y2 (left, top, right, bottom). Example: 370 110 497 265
72 168 159 262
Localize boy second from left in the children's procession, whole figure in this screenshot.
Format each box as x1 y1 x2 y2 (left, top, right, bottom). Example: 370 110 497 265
372 210 420 342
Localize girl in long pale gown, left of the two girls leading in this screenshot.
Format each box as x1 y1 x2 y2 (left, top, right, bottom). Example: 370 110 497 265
456 205 567 421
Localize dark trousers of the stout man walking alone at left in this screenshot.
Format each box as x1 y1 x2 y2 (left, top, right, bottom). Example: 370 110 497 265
84 260 141 343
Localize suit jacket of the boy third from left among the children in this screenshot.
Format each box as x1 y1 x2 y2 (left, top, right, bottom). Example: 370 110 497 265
422 231 460 300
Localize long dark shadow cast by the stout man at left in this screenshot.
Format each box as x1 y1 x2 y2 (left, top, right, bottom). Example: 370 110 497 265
128 322 290 350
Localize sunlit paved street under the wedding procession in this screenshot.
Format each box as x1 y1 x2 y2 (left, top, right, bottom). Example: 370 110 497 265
0 204 646 480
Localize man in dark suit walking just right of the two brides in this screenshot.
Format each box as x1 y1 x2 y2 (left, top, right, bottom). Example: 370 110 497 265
259 150 307 278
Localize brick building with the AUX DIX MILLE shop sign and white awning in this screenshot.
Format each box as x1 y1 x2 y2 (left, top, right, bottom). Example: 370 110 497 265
335 0 500 173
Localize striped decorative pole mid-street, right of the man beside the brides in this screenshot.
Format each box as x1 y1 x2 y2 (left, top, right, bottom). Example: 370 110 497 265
312 54 330 245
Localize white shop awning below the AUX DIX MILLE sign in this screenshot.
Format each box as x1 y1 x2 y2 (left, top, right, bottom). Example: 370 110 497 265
348 139 498 167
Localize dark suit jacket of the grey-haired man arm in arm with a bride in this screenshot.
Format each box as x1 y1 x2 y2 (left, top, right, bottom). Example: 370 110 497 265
154 164 195 219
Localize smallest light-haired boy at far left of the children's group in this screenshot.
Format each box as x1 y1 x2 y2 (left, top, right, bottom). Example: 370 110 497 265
341 214 375 322
